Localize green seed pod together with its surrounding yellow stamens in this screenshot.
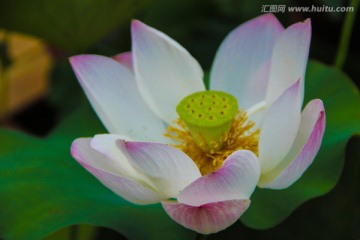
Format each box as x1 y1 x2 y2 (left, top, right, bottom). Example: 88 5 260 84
164 91 259 175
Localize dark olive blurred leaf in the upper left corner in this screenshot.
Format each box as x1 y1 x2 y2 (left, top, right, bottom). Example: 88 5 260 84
0 0 148 52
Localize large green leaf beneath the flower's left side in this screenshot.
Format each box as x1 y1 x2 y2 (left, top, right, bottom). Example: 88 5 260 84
0 104 193 240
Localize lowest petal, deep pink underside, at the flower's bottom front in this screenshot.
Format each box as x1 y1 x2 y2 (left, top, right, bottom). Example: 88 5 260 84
162 200 250 234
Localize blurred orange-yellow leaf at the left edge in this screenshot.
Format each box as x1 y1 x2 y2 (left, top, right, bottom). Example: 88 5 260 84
0 30 53 118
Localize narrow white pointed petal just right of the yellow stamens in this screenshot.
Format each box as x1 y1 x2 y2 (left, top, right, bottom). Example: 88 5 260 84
259 80 301 174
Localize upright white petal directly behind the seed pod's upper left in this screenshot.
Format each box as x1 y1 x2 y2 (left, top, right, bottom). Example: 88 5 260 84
131 20 205 123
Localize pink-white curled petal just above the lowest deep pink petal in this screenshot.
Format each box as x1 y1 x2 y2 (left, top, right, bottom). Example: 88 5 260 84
177 150 260 207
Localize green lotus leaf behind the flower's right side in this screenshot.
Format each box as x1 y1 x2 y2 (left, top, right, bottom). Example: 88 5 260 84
241 61 360 229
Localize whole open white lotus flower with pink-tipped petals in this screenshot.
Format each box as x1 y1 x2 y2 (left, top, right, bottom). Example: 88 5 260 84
70 14 325 234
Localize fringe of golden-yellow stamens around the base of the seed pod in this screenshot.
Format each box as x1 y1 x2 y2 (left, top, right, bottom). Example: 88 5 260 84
164 110 260 175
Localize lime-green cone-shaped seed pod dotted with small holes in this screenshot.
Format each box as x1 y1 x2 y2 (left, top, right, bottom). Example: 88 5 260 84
176 91 238 153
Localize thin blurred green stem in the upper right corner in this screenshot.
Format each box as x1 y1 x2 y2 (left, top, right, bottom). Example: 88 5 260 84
335 0 360 69
